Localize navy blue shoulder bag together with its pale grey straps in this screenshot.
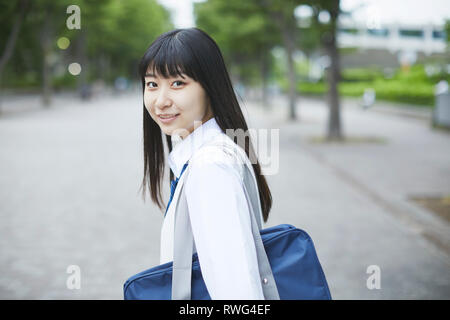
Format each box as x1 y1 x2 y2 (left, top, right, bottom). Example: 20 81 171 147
123 145 331 300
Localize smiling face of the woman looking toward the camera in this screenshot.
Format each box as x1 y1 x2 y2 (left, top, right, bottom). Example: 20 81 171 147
144 68 213 139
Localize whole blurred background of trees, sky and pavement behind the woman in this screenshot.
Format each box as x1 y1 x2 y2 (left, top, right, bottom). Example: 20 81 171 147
0 0 450 299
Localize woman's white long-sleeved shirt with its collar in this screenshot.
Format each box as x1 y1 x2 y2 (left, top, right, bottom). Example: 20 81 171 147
160 118 264 300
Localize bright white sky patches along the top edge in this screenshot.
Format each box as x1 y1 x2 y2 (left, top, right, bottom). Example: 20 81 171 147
158 0 450 28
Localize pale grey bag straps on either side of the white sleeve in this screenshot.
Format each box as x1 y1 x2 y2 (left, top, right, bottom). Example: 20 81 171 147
172 152 280 300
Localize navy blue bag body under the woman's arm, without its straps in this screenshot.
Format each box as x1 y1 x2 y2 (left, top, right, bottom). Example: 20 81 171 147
124 224 331 300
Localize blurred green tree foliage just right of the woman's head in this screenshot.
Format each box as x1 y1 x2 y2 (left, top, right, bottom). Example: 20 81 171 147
194 0 281 85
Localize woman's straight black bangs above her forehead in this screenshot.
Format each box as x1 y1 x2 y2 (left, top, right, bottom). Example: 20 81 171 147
139 36 197 80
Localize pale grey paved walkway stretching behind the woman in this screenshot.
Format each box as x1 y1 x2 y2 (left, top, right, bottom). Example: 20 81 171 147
0 94 450 299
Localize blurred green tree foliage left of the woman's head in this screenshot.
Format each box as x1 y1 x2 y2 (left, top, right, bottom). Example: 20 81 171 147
0 0 173 87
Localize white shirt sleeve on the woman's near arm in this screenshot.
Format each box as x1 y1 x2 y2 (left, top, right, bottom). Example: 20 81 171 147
185 151 264 300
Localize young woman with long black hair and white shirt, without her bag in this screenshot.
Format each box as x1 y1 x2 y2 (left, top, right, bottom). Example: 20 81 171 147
139 28 272 299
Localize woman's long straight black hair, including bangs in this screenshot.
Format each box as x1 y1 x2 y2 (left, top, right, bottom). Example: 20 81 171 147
139 28 272 222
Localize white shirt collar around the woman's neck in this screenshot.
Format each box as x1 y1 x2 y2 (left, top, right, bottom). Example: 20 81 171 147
169 117 222 178
